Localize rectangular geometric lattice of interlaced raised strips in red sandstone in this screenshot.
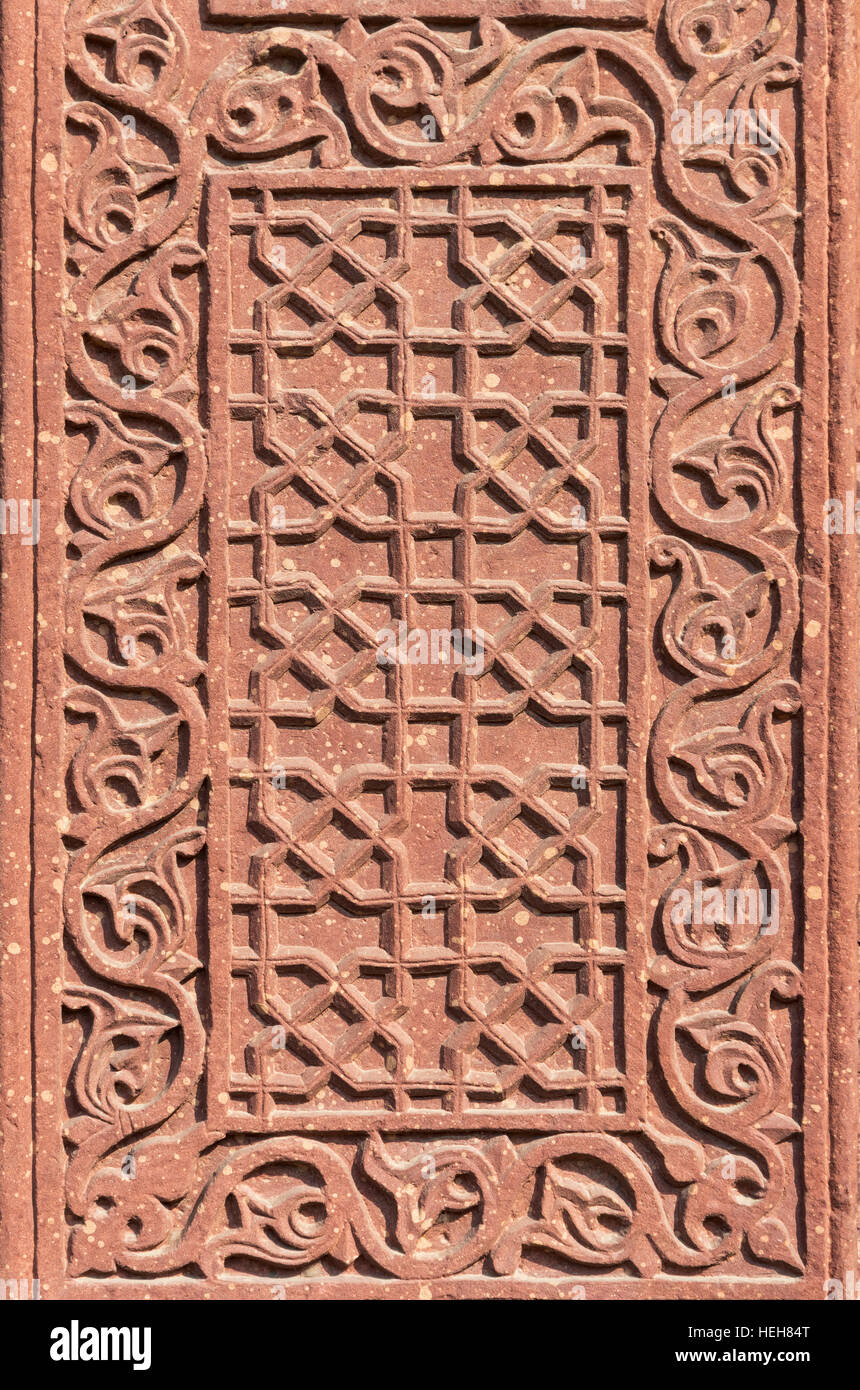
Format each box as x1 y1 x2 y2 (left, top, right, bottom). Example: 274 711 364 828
211 170 640 1129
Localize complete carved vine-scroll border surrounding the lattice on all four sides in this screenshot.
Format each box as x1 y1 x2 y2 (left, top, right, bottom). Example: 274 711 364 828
64 0 803 1280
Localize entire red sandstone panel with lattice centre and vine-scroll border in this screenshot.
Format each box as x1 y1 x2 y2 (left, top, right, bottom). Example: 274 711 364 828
4 0 854 1300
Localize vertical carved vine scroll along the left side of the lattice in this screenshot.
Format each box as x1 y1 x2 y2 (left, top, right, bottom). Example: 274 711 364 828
64 0 206 1213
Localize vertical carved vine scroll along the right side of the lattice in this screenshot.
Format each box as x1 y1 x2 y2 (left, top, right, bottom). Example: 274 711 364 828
650 0 803 1269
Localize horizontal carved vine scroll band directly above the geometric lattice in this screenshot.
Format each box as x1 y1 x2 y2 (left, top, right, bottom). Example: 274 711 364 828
207 19 647 168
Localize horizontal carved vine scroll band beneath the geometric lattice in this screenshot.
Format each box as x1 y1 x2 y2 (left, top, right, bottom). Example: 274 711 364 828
72 1130 785 1279
